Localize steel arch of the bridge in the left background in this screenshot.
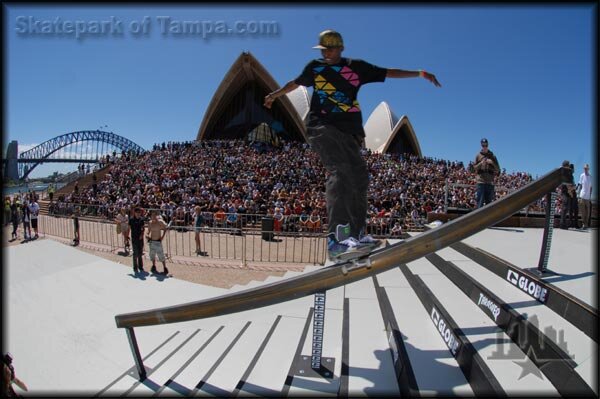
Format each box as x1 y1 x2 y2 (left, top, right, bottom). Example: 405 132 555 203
18 130 145 179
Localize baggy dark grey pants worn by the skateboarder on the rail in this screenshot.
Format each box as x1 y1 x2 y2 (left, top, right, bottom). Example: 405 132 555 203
307 125 369 238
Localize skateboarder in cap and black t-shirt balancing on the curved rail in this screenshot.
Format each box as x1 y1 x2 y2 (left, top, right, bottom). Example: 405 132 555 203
264 30 441 259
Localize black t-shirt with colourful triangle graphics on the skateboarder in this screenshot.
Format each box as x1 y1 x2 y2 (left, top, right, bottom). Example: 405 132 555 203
294 58 387 138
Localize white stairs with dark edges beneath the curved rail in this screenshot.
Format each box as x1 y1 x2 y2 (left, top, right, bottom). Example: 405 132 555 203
92 238 598 397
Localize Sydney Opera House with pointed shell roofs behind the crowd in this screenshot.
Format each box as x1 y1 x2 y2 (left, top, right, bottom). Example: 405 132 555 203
196 52 422 157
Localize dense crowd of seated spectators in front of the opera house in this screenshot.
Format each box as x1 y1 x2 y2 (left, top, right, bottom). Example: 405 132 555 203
48 140 543 234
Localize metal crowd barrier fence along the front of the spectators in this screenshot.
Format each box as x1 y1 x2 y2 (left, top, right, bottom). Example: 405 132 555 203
38 215 327 266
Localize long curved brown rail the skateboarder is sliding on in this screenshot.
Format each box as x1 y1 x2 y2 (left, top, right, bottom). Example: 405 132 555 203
115 167 573 332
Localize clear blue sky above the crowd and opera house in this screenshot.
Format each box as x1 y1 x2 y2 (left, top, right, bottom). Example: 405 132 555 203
3 3 598 184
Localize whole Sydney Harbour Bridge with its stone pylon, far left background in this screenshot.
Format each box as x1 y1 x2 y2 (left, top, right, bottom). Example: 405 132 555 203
3 130 145 180
